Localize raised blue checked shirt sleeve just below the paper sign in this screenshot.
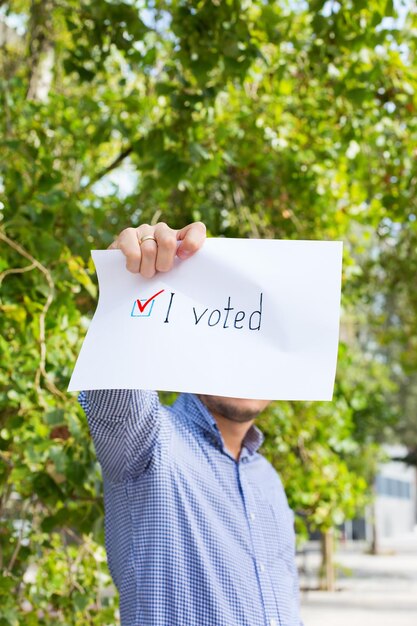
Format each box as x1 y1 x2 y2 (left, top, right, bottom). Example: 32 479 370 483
78 389 162 482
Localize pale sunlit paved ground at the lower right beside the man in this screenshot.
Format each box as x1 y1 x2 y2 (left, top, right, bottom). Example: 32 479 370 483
300 536 417 626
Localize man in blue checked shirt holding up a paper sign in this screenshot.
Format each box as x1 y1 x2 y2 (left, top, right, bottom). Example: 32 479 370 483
80 222 300 626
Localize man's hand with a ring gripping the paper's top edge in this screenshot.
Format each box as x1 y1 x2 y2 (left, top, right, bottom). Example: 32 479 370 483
109 222 206 278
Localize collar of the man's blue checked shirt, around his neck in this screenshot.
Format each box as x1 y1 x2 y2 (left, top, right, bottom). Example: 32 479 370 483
175 393 264 455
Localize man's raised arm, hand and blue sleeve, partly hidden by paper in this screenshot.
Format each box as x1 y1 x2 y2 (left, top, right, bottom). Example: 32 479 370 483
79 222 206 482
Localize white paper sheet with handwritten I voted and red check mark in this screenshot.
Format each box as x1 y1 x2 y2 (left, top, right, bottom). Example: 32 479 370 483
69 239 342 400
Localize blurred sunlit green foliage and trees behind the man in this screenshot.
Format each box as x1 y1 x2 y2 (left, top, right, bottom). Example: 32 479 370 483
0 0 417 626
